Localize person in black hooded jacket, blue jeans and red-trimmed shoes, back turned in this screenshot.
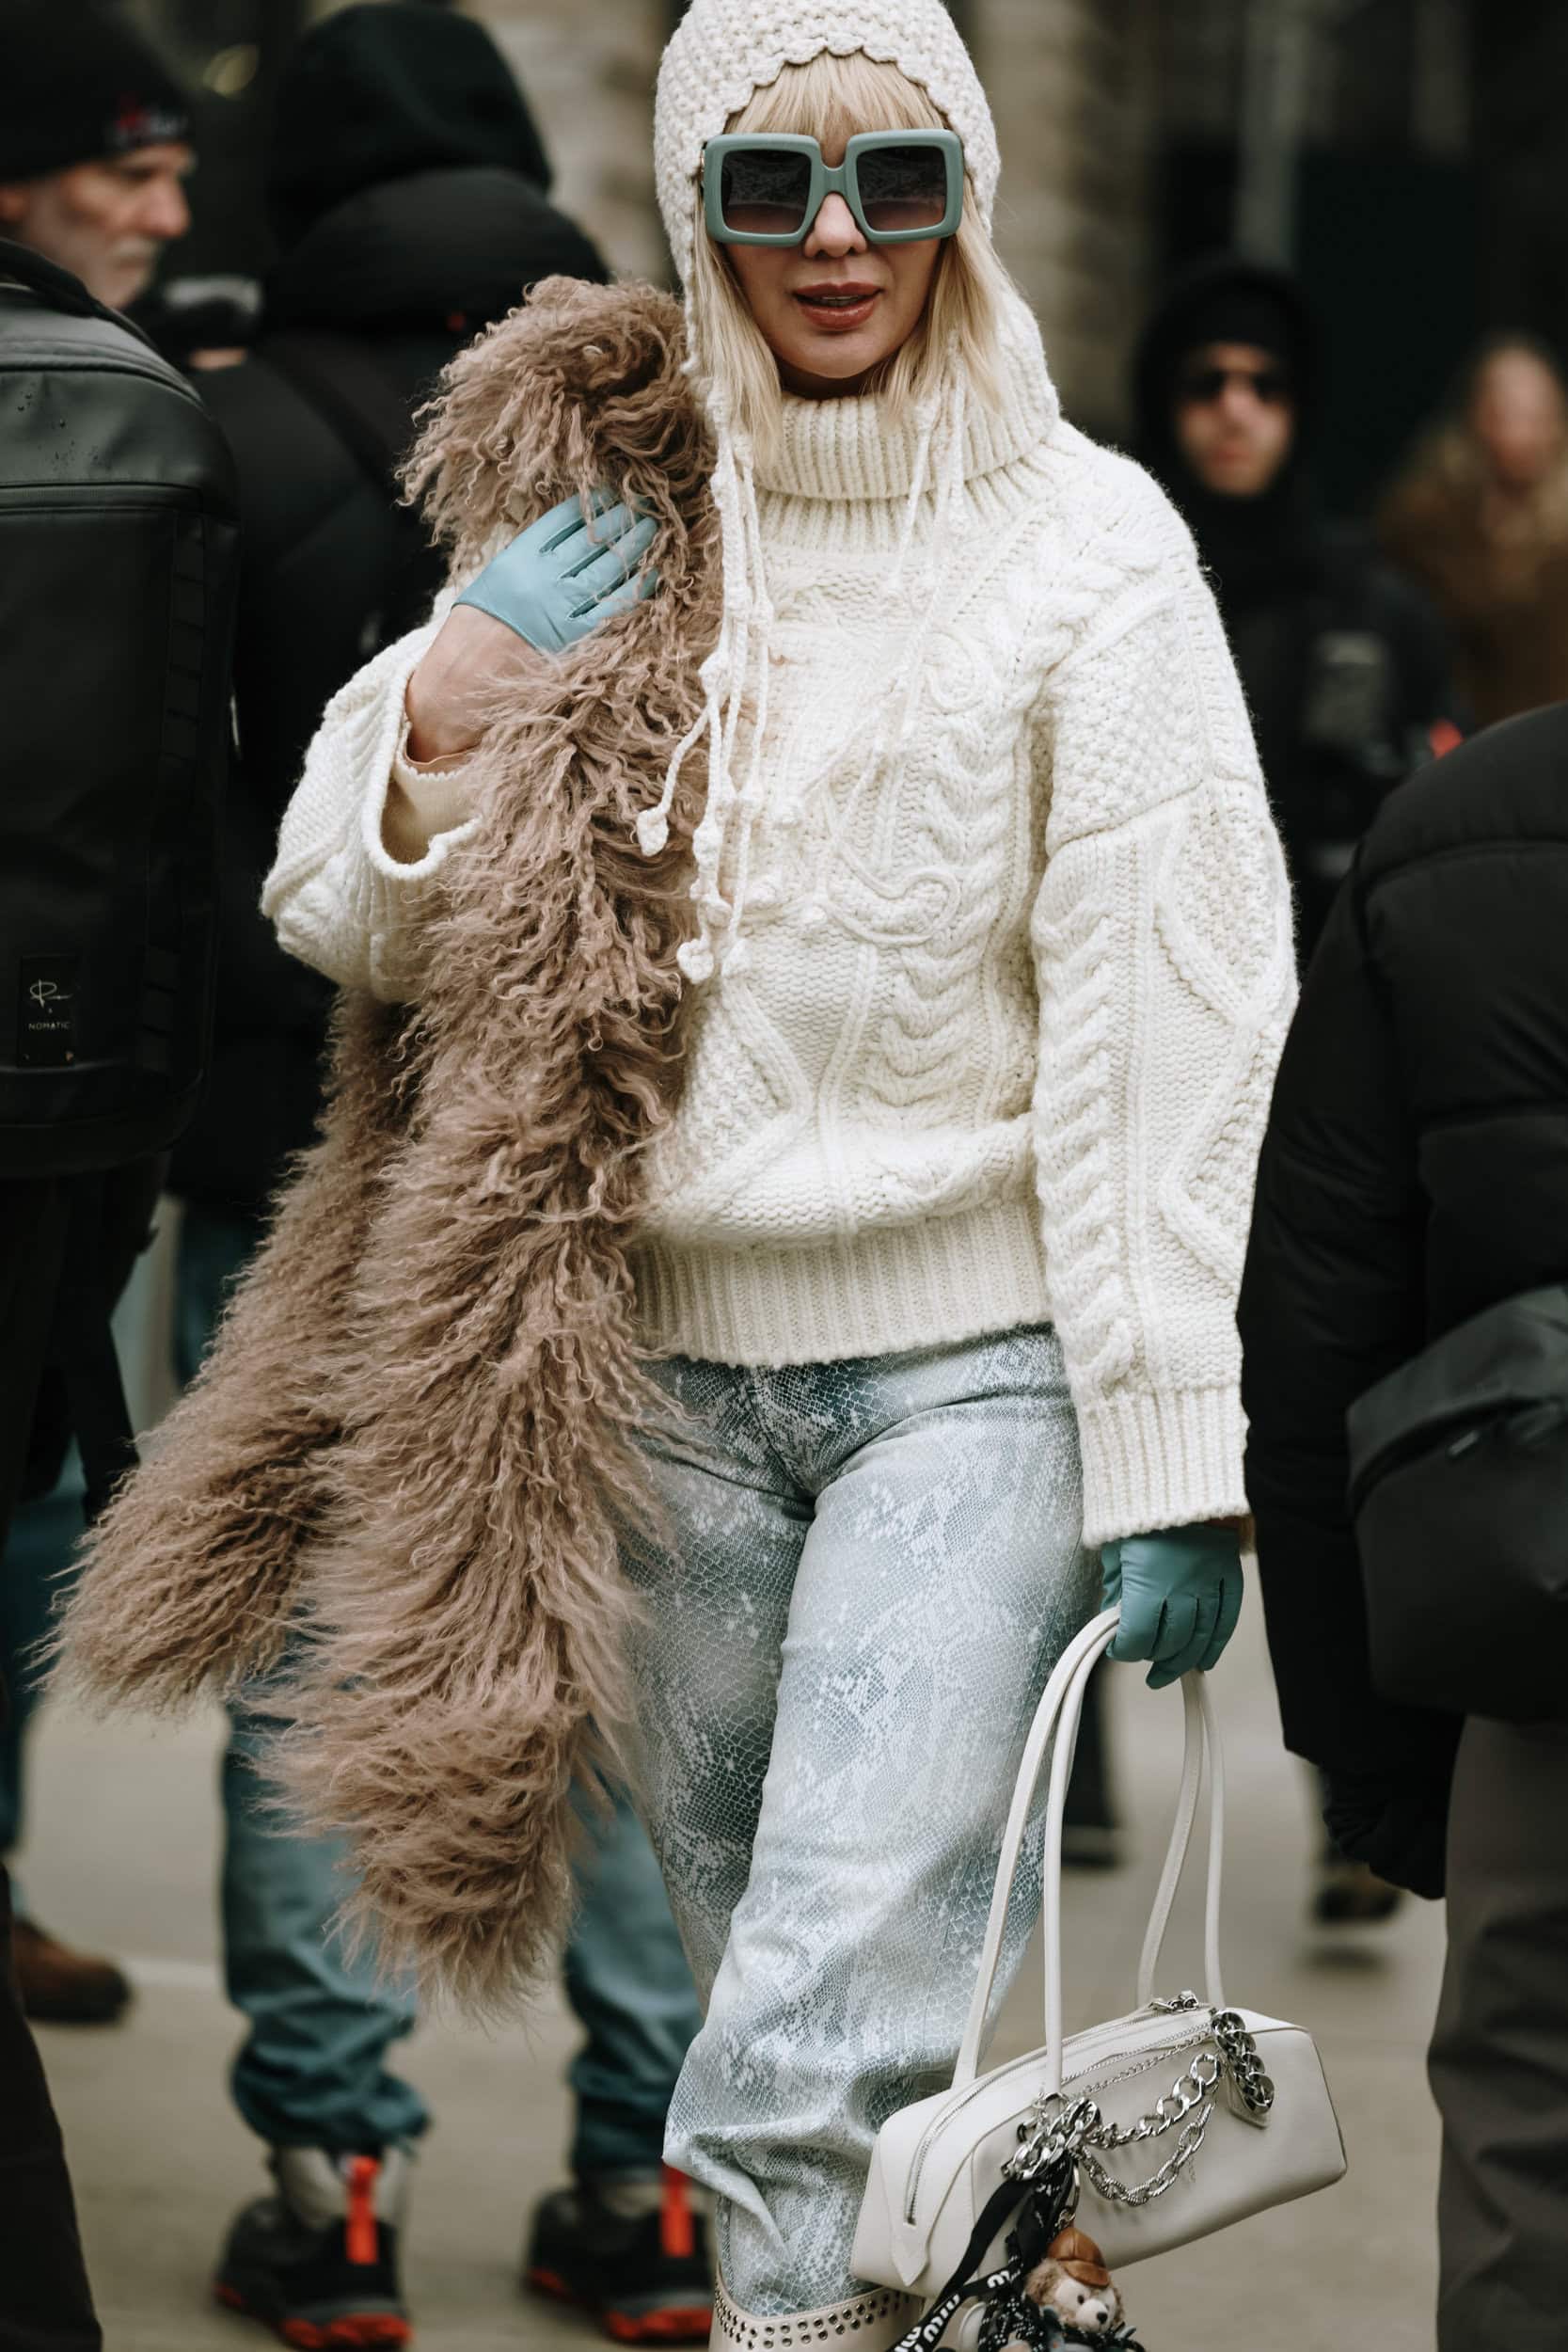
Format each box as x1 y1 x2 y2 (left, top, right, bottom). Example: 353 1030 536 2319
171 18 710 2345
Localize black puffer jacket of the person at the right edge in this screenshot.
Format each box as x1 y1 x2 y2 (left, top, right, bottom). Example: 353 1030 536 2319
1239 704 1568 1894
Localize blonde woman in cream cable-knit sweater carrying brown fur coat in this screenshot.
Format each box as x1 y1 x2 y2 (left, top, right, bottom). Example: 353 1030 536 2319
61 0 1291 2352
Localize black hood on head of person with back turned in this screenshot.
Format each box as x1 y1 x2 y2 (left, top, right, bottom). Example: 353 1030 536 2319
265 0 550 252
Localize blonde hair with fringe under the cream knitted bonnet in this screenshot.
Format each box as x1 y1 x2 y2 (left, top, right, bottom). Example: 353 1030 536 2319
691 50 1013 454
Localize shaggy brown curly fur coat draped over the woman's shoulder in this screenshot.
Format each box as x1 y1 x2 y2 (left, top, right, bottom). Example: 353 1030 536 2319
61 280 720 2007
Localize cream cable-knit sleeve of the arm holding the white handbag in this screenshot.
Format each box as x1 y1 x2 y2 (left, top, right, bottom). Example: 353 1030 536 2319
1032 478 1295 1543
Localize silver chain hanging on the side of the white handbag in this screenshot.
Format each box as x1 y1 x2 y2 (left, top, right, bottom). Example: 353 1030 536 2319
1004 1993 1275 2206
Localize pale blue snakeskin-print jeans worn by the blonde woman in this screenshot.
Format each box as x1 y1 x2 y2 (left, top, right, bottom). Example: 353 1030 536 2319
626 1329 1096 2317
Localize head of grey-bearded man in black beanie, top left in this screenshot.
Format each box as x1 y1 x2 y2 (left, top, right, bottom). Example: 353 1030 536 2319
0 0 195 310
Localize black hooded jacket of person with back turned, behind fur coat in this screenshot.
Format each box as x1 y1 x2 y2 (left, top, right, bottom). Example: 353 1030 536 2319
171 5 607 1214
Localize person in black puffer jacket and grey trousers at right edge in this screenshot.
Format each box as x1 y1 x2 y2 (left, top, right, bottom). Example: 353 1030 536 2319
1239 704 1568 2352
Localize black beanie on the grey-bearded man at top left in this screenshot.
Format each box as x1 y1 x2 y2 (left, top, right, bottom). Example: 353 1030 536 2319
0 0 190 182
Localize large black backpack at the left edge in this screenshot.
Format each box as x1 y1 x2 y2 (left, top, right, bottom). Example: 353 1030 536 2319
0 240 237 1179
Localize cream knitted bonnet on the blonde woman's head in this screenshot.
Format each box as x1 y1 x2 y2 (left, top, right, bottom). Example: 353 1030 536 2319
654 0 1002 280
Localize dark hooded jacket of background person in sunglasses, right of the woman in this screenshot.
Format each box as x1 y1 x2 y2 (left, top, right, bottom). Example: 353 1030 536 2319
1133 254 1455 962
